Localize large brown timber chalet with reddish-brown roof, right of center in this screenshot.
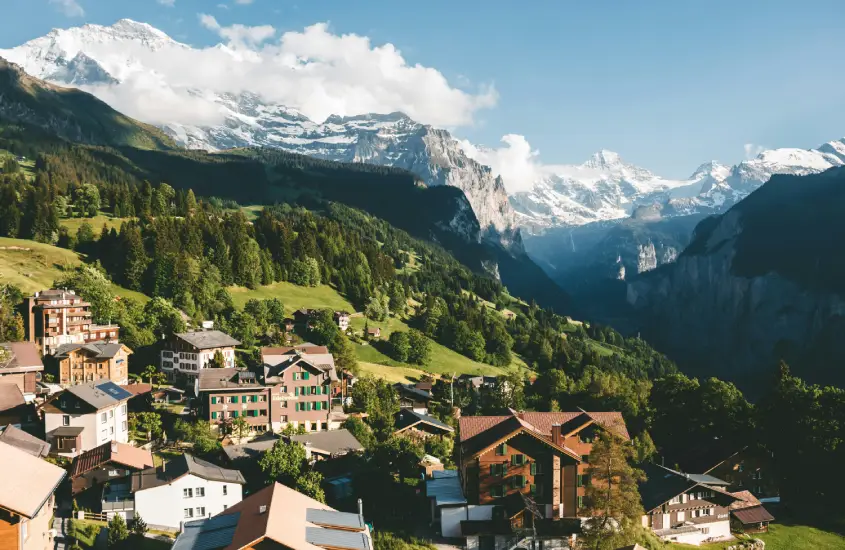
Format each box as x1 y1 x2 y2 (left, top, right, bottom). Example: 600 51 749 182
458 410 629 545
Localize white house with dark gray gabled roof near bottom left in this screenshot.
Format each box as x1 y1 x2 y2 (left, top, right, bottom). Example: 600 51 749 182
103 454 245 529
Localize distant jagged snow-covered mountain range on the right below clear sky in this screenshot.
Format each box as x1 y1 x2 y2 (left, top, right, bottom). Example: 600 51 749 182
510 143 845 231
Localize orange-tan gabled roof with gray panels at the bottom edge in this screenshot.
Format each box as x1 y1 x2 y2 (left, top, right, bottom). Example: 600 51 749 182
173 483 372 550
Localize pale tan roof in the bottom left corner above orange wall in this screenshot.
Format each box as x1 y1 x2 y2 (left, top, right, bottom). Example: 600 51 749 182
0 443 65 519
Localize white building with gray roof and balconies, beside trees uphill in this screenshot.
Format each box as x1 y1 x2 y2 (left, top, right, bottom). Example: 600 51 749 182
161 330 240 380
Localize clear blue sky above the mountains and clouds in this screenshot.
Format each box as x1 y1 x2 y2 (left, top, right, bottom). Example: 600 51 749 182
0 0 845 177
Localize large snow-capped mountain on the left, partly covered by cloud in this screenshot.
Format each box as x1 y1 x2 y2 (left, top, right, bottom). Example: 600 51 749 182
0 19 522 246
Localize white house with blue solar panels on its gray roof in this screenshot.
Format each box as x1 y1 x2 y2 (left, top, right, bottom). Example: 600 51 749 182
43 380 132 457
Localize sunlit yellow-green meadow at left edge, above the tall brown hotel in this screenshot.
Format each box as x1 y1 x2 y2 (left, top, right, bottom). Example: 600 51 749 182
0 237 149 303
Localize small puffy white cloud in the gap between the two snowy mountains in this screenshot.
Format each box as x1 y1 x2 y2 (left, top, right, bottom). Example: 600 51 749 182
460 134 547 193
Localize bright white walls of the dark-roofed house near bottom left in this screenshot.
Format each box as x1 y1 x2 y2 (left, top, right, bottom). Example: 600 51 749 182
135 474 243 529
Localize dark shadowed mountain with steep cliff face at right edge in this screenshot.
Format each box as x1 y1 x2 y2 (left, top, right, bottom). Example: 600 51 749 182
627 170 845 392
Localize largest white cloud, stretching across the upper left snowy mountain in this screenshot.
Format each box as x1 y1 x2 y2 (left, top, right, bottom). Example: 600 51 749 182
68 19 497 128
